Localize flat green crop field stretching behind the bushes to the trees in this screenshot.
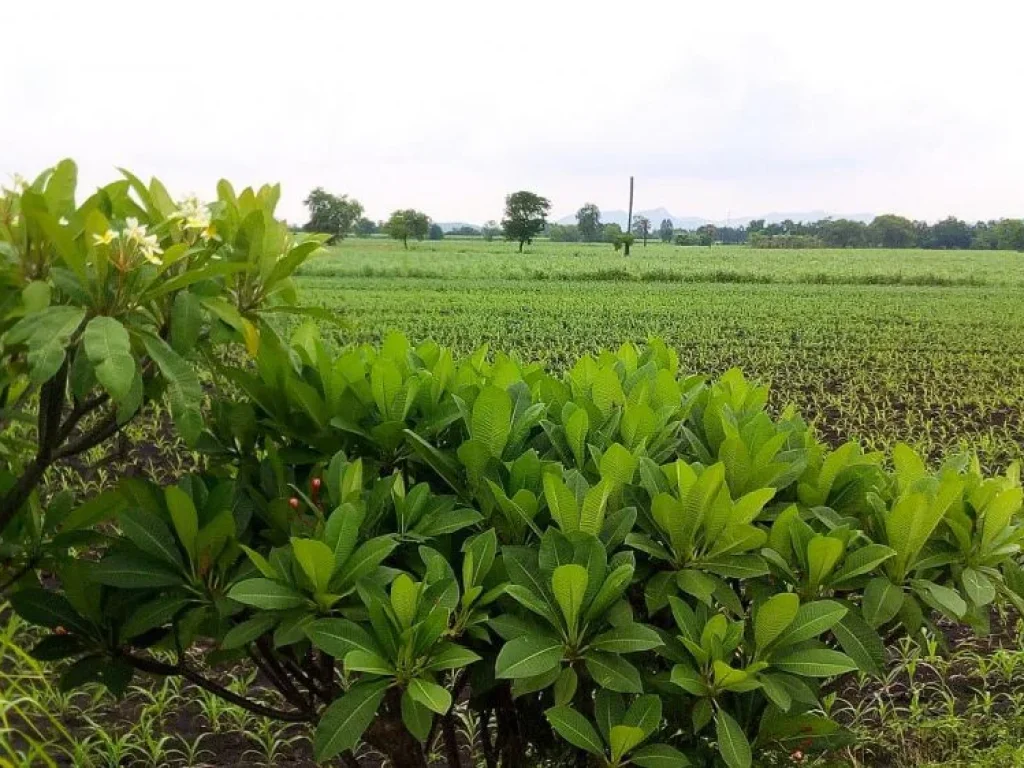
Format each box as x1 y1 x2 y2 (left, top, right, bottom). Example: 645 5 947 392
300 239 1024 468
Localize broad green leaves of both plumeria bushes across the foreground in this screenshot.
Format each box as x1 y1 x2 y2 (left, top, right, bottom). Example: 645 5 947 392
0 159 1024 768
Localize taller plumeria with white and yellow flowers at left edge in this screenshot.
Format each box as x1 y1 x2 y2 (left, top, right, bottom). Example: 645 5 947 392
0 160 322 592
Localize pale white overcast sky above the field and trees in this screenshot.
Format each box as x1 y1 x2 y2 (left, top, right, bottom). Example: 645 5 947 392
8 0 1024 222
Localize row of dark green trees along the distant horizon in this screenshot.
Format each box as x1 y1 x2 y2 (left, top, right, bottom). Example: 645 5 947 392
303 187 1024 252
